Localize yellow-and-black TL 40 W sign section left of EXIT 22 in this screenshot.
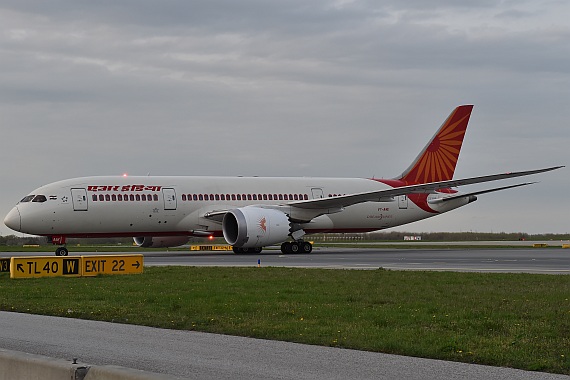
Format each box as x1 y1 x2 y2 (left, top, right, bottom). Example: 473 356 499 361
10 256 81 278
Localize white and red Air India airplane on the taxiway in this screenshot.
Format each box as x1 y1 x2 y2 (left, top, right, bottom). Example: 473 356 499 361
4 105 564 256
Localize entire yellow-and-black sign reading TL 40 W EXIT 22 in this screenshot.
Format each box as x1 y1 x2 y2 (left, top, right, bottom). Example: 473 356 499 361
10 255 144 278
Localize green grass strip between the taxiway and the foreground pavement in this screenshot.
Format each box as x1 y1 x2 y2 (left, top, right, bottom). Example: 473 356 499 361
0 267 570 374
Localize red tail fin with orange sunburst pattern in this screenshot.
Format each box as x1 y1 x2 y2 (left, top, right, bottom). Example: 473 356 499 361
399 105 473 184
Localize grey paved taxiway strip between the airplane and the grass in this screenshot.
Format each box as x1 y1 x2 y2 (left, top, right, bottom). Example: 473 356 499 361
140 248 570 274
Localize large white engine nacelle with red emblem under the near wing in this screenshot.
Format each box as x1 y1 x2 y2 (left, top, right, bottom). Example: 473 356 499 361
222 207 290 248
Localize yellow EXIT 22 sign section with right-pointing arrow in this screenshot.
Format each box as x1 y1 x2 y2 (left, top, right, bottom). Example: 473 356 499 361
81 255 144 276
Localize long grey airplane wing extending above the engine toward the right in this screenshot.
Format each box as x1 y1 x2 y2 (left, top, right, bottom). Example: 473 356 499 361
288 166 564 209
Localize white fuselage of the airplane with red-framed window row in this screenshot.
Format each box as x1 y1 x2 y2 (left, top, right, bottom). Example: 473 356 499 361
5 177 468 237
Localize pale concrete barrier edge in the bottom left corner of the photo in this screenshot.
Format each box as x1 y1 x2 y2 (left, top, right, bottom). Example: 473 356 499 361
0 348 178 380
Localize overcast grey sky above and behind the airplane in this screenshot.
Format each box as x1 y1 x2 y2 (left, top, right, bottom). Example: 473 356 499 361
0 0 570 235
